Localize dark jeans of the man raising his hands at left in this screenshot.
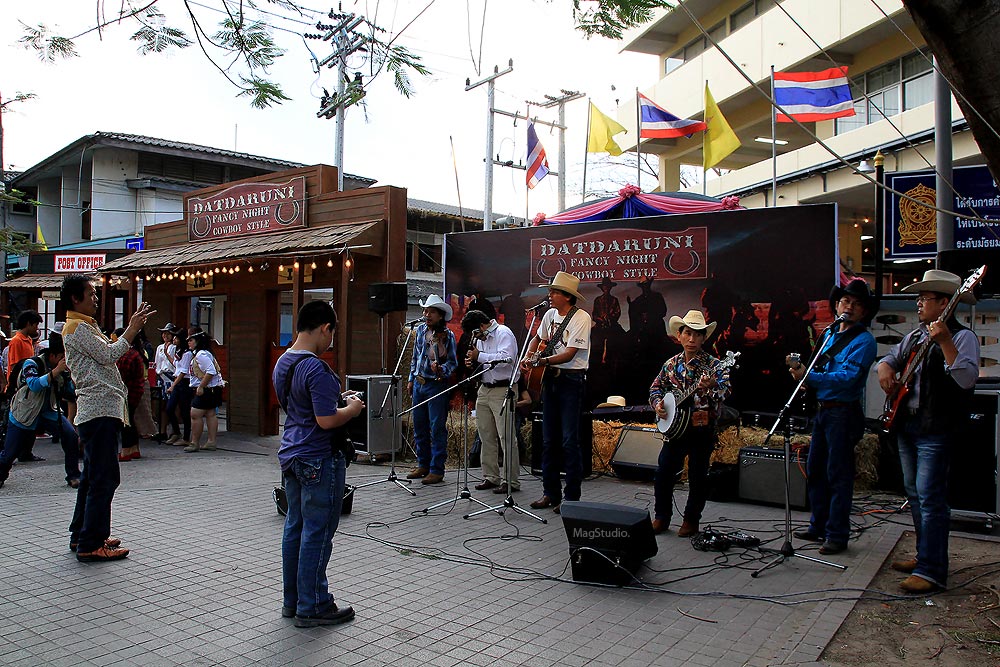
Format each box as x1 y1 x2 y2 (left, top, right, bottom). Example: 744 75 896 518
69 417 122 553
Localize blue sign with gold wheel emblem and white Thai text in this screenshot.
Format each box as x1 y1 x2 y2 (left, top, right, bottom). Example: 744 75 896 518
885 166 1000 259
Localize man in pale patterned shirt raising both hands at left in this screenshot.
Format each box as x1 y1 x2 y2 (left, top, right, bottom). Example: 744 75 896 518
59 274 156 563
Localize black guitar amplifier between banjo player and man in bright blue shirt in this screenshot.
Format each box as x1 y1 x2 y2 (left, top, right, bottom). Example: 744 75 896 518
739 447 809 510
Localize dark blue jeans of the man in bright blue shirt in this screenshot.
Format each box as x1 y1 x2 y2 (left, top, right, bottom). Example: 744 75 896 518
806 402 865 545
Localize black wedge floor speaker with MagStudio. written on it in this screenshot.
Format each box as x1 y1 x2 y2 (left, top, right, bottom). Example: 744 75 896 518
559 500 657 586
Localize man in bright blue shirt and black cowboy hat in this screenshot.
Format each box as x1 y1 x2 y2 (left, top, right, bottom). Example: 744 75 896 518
789 278 879 555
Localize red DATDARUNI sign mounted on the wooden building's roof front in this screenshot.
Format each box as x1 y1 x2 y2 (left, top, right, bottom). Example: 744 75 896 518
185 176 306 241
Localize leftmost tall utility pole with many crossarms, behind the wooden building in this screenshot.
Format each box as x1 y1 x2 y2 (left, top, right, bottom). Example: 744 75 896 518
304 9 365 191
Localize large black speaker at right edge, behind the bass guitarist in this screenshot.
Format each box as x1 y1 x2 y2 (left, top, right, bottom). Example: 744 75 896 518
948 385 1000 514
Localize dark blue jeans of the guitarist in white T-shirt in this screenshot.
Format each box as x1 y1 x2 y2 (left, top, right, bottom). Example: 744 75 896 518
542 369 586 503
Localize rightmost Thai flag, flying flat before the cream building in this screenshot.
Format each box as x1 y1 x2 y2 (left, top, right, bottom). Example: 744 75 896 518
774 67 854 123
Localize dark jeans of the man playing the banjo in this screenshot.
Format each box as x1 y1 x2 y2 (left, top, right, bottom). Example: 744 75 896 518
653 426 715 524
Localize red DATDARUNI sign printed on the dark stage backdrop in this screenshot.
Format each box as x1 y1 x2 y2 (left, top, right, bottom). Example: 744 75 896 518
530 227 708 284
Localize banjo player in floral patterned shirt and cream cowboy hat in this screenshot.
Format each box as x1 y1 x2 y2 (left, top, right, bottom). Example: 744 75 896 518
649 310 730 537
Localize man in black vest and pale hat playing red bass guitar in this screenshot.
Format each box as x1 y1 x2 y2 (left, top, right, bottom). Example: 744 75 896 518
877 269 979 593
